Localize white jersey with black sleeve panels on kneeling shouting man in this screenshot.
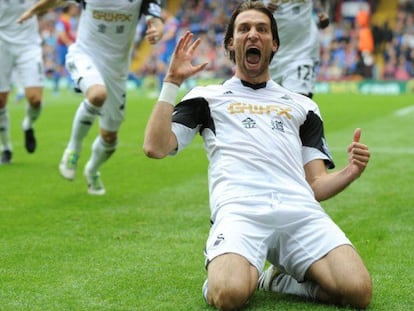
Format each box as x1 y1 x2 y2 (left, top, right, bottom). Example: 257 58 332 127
173 77 334 219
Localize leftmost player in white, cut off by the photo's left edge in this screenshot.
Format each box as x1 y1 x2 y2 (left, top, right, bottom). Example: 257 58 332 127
0 0 44 164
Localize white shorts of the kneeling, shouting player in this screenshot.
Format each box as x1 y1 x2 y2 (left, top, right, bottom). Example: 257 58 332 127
205 194 352 282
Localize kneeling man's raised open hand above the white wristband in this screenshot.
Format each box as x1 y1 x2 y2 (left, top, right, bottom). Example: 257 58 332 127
165 31 208 85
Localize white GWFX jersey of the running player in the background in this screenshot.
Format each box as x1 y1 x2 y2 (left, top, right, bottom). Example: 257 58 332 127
65 0 161 78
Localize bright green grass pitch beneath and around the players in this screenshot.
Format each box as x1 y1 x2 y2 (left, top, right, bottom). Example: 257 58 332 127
0 90 414 311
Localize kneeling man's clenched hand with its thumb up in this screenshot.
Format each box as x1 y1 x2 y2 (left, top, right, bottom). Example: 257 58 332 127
348 128 371 178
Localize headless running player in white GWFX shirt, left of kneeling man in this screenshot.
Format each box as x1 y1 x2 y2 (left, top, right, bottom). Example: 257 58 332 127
19 0 163 195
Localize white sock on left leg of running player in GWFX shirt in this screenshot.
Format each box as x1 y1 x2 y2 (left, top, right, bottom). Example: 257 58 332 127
68 98 101 154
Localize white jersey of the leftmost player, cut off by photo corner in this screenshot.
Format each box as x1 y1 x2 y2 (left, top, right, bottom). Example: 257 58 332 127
0 0 41 46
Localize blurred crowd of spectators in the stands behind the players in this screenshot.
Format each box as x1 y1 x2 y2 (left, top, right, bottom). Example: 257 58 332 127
36 0 414 91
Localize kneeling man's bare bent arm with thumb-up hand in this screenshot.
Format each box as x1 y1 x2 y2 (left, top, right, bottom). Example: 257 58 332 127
305 128 371 201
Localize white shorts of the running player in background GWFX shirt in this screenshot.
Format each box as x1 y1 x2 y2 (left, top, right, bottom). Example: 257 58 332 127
66 49 126 132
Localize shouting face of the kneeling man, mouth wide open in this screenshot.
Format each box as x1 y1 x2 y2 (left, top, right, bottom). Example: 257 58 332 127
229 10 277 83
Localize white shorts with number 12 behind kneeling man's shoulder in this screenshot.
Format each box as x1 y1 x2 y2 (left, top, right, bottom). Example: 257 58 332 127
271 55 318 95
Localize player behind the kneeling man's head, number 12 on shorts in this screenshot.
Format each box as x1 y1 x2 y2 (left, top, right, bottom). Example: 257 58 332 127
265 0 329 98
